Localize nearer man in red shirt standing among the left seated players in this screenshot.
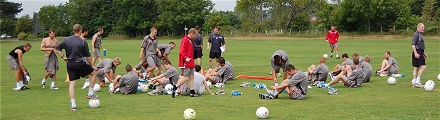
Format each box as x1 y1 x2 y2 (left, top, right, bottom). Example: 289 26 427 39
171 28 198 98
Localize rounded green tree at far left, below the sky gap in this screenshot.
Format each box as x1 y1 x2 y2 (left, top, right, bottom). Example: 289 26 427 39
15 14 34 34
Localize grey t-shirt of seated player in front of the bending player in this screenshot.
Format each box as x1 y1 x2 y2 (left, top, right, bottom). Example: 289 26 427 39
287 70 308 94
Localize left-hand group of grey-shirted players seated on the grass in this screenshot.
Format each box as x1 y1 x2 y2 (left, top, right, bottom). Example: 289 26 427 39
84 57 234 95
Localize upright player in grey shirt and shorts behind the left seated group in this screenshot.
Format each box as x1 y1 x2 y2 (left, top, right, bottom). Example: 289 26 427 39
139 27 162 78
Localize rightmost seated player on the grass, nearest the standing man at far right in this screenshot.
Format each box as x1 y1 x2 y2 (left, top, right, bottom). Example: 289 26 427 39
376 51 399 76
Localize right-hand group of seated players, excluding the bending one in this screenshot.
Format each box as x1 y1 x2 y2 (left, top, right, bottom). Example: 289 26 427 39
259 51 398 100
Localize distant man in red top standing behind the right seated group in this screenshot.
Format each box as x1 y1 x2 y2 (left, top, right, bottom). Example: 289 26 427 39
325 25 339 59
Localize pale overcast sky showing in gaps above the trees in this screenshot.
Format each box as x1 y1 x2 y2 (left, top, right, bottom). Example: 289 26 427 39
7 0 236 17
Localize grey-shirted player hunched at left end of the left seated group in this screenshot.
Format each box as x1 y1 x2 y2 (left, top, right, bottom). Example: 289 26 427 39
96 57 121 87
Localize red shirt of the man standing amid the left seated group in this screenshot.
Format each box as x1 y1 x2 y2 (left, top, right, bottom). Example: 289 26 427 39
179 36 195 68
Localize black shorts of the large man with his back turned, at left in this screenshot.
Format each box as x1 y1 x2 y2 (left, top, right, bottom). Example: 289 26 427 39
67 61 93 81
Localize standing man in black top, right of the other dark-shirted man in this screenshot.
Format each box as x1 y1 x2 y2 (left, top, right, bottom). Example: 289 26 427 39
207 26 226 68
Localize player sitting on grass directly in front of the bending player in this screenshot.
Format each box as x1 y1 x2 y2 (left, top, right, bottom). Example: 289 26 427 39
259 64 308 100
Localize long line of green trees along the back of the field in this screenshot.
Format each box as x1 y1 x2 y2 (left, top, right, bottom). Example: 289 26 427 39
0 0 440 37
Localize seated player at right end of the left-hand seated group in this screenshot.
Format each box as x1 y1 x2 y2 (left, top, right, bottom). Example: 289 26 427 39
205 57 232 87
